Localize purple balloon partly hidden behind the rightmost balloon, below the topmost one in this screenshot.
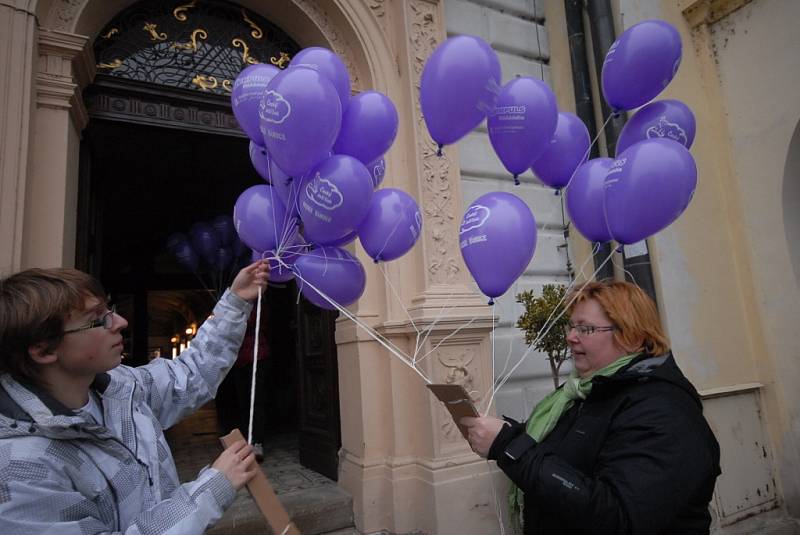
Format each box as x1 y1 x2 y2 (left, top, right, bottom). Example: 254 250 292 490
617 99 695 155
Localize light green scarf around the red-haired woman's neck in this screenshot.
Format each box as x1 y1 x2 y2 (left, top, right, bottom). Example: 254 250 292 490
508 353 639 532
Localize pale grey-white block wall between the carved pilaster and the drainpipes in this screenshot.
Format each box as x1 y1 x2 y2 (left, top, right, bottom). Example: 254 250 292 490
445 0 571 420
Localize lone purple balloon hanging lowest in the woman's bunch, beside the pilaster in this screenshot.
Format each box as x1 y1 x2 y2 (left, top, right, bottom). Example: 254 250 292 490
459 191 536 304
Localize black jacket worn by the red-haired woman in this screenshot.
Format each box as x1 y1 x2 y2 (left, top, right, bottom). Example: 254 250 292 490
489 353 720 535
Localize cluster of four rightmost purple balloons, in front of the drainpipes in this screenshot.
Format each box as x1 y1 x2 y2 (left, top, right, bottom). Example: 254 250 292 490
566 20 697 244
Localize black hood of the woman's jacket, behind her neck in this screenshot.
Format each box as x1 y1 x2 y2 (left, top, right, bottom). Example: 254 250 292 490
592 351 703 409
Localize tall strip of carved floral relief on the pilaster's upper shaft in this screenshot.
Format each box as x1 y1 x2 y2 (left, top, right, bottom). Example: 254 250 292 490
409 0 461 284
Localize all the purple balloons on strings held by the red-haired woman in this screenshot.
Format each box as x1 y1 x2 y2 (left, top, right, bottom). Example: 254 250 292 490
420 20 697 306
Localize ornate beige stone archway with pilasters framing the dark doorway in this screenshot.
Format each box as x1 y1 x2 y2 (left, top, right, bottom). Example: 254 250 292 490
0 0 497 533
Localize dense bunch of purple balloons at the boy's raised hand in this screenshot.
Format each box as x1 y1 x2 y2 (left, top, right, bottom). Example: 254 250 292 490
231 47 422 309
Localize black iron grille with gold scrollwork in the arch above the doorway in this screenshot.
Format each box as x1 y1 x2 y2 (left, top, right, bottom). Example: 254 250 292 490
94 0 300 95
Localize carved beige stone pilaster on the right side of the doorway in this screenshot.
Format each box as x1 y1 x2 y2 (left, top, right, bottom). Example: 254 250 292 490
336 0 503 534
